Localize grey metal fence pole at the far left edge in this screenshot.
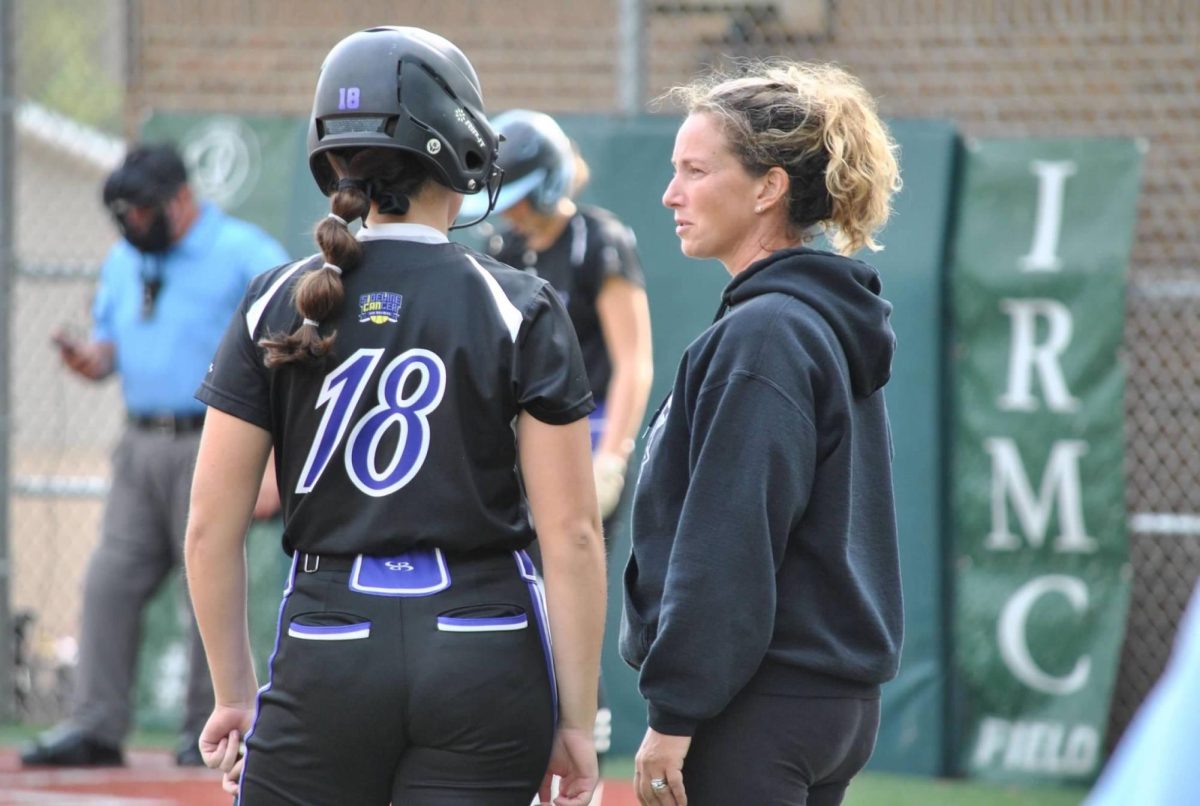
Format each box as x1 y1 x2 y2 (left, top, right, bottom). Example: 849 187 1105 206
0 0 17 721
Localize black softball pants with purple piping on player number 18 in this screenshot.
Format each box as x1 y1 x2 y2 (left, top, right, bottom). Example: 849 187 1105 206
239 553 557 806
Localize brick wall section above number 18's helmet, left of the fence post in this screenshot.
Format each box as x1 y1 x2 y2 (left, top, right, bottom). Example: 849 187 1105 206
131 0 617 114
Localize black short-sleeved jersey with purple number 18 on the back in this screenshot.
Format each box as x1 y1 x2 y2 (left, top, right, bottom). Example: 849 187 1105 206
197 224 594 554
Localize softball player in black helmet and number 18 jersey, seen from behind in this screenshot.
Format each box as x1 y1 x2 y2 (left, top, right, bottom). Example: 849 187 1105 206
187 28 604 806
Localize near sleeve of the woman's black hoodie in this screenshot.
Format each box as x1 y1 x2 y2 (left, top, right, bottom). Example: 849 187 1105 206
640 372 816 735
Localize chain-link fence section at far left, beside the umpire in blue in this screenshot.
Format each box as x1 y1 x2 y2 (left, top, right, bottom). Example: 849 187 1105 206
5 0 125 722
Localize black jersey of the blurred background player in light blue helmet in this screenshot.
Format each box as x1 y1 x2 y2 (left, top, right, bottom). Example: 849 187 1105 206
487 205 646 402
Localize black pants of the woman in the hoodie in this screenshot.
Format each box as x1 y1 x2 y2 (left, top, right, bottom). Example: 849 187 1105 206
683 685 880 806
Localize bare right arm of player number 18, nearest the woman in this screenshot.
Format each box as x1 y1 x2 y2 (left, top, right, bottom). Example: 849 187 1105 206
517 411 605 802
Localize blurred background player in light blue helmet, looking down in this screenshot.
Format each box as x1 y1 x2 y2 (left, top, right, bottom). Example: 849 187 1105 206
460 109 654 527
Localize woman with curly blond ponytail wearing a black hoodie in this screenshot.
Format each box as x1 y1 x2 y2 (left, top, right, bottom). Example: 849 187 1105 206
620 64 902 806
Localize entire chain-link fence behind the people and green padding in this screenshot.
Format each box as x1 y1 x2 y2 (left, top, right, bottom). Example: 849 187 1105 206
6 0 1200 758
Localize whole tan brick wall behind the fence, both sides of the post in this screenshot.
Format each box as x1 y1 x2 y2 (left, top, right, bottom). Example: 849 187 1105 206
130 0 1200 273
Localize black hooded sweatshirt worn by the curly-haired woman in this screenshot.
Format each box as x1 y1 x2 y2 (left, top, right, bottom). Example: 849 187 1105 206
620 248 904 735
